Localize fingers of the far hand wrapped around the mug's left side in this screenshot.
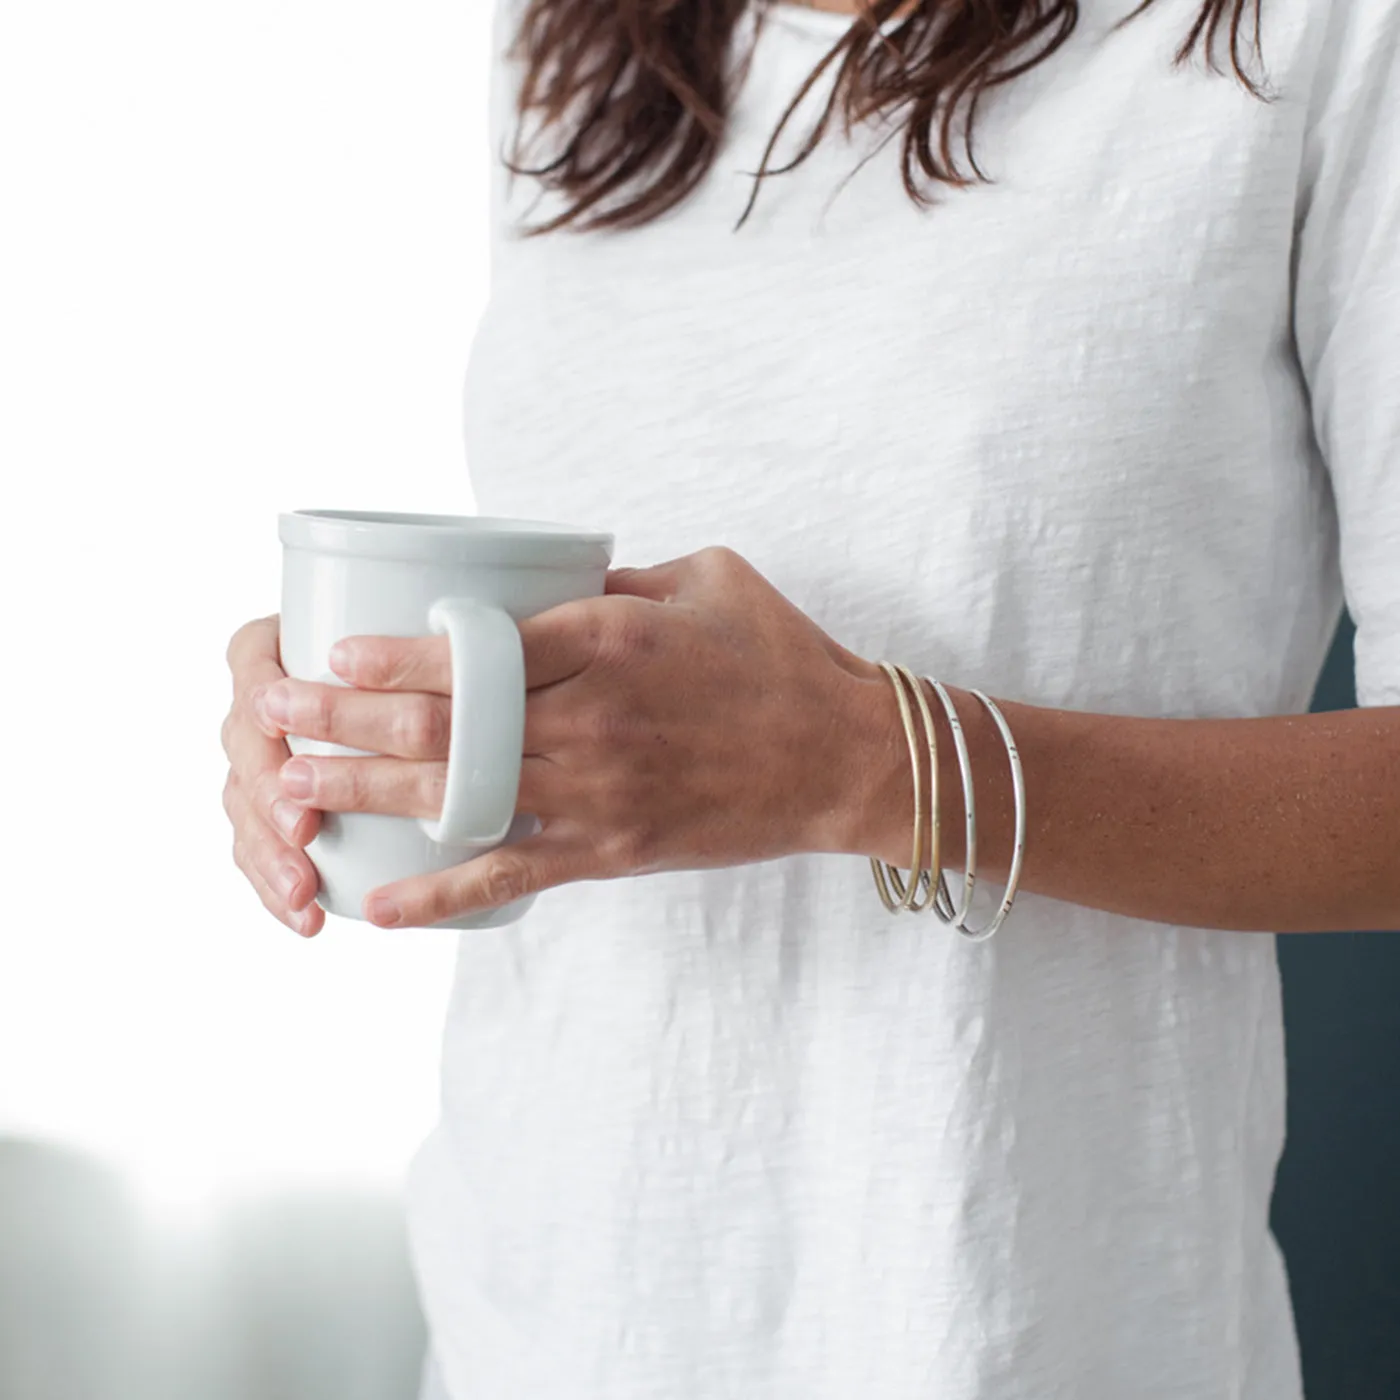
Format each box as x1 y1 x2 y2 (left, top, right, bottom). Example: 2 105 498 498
221 613 326 938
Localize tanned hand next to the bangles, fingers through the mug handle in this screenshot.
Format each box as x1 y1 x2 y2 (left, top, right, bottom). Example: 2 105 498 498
255 547 889 927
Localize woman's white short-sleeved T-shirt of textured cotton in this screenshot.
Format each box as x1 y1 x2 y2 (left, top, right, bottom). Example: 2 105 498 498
407 0 1400 1400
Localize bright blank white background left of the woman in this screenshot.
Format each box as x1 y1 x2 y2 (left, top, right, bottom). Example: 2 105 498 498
0 0 490 1219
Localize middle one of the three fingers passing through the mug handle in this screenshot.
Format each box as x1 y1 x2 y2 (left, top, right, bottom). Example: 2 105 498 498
252 678 452 766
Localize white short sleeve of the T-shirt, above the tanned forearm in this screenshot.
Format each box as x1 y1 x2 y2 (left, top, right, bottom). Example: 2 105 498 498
1294 0 1400 706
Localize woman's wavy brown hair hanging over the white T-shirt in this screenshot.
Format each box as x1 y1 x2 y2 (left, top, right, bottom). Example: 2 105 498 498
503 0 1263 234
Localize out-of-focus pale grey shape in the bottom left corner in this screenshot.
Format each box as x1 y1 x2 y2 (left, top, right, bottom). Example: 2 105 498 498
0 1138 426 1400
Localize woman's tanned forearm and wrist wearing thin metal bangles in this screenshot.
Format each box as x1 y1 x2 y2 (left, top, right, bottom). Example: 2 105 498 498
843 673 1400 932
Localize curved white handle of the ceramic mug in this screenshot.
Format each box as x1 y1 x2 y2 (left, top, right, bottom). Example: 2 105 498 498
419 598 525 847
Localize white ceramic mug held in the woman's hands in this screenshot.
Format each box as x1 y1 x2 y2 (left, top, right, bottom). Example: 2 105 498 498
277 510 613 928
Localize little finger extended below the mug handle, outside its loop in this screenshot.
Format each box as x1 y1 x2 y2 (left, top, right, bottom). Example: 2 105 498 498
364 823 605 928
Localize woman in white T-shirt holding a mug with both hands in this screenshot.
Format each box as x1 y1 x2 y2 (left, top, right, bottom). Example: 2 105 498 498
225 0 1400 1400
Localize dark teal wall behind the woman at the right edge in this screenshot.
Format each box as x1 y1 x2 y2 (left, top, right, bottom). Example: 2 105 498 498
1273 619 1400 1400
